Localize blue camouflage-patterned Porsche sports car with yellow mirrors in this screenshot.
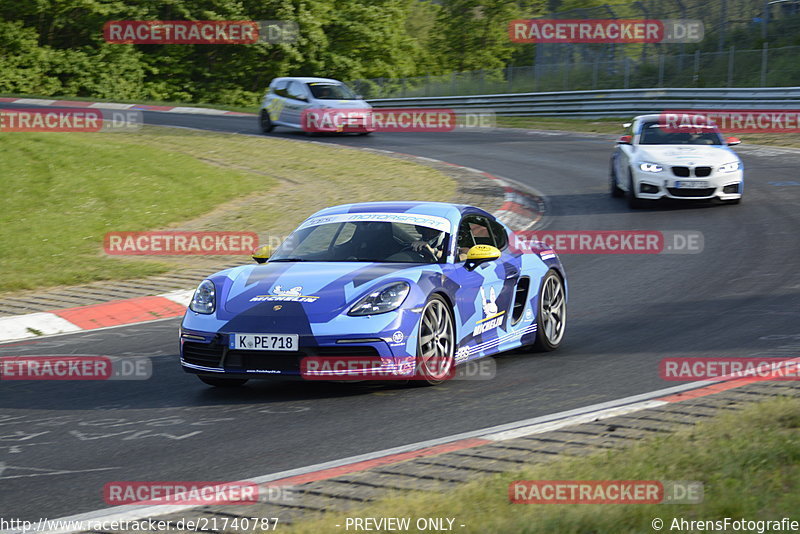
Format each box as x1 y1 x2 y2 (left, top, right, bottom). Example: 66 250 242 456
180 202 567 386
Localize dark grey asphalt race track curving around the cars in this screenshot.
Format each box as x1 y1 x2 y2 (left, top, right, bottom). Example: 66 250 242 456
0 112 800 520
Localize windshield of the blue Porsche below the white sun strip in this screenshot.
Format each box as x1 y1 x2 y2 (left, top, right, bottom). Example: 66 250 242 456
269 221 449 263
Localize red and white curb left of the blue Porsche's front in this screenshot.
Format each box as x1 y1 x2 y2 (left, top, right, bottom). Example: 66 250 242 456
0 289 194 341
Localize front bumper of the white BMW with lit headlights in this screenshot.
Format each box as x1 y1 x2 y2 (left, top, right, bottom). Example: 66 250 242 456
633 167 744 200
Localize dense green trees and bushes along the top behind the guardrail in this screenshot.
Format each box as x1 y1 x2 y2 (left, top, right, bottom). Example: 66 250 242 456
0 0 800 106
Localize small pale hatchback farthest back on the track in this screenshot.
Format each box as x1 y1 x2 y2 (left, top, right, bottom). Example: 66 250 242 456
259 77 374 135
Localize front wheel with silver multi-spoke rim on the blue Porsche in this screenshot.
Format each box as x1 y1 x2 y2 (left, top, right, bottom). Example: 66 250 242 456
413 295 455 386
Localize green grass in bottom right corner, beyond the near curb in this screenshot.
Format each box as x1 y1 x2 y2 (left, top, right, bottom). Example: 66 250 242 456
282 399 800 534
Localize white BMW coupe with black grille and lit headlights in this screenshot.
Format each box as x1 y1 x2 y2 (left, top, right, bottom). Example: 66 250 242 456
609 114 744 208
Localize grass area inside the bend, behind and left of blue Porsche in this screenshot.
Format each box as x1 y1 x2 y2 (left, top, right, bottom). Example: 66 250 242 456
0 126 456 292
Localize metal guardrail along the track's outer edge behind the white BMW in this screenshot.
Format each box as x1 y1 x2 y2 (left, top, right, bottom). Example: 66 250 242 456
368 87 800 117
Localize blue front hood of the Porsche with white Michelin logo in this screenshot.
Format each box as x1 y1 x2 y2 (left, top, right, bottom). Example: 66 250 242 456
212 262 424 320
